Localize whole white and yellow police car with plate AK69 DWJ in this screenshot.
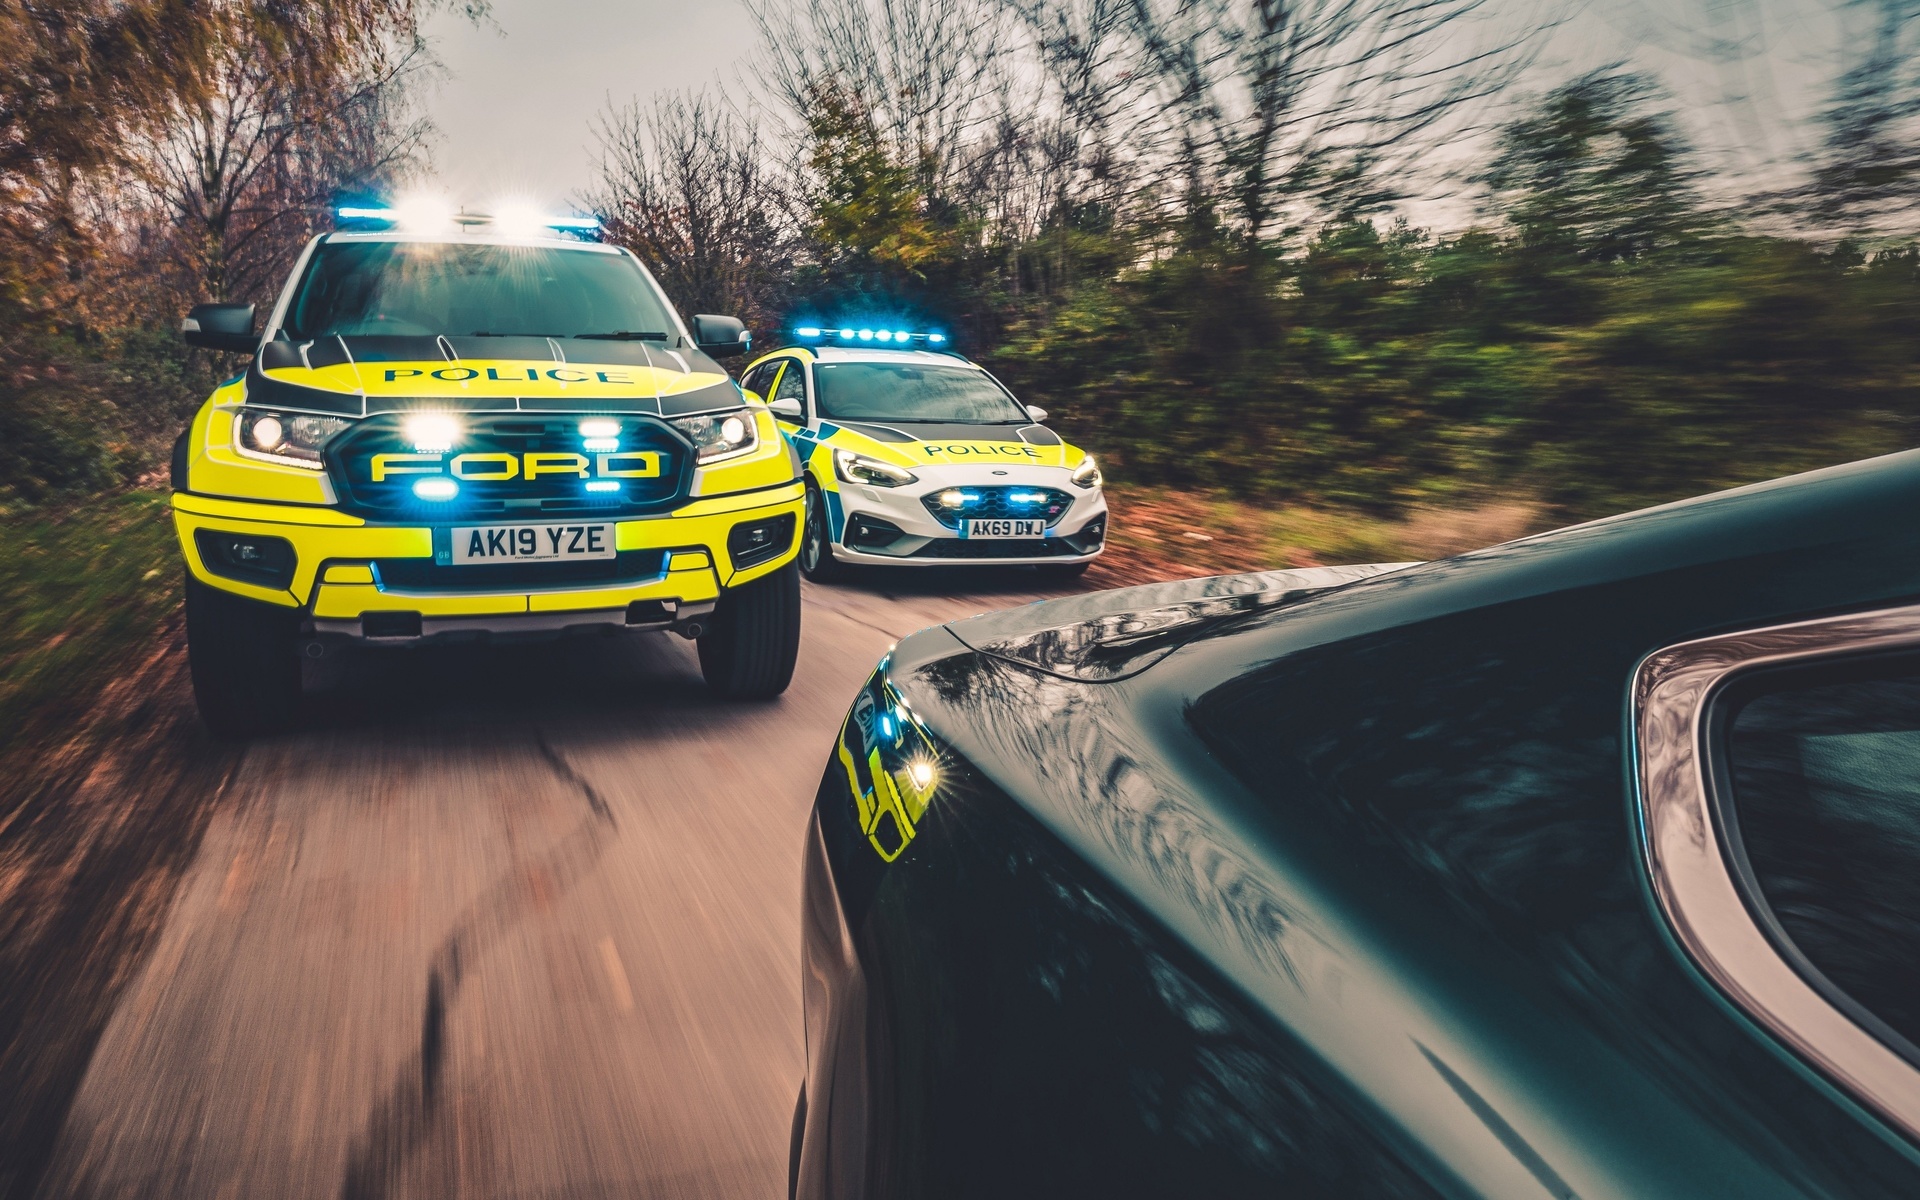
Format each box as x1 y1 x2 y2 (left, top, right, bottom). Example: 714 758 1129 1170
741 326 1108 580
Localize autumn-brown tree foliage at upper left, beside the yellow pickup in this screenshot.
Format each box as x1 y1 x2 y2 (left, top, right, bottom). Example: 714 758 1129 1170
0 0 455 513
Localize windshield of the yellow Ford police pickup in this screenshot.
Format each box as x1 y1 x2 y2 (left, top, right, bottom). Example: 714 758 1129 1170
286 242 678 342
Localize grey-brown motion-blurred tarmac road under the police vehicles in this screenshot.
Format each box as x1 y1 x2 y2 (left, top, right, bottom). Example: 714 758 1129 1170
42 572 1067 1200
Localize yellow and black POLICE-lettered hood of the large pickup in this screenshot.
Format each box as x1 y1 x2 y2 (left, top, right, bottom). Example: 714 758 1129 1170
246 336 743 417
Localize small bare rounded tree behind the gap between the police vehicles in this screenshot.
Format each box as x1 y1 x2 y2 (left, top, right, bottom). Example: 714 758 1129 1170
586 94 803 330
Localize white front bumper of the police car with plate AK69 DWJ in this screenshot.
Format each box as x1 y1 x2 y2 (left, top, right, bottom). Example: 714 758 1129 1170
826 465 1108 566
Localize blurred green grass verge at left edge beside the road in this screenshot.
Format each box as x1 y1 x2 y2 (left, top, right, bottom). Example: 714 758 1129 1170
0 492 180 762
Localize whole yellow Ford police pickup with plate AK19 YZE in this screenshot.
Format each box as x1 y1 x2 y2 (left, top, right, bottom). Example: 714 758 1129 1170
173 209 804 733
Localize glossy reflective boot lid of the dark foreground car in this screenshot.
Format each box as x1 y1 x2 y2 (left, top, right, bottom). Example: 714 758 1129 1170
921 563 1415 684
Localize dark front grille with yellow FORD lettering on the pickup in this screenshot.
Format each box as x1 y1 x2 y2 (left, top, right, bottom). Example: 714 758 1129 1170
326 413 693 524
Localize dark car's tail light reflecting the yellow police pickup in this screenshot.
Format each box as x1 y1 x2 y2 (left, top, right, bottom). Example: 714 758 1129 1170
835 659 941 862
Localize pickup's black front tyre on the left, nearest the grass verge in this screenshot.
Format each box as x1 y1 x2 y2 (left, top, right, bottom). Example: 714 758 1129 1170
186 574 300 737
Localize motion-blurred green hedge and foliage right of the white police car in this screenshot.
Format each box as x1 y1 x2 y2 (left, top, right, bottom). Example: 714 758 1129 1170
779 73 1920 518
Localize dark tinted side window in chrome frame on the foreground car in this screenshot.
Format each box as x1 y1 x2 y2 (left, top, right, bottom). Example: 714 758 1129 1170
1726 662 1920 1044
